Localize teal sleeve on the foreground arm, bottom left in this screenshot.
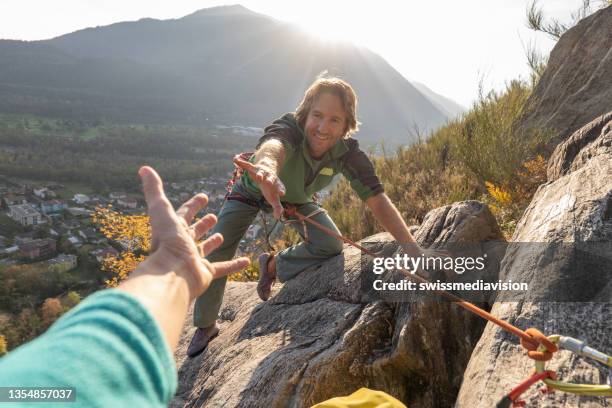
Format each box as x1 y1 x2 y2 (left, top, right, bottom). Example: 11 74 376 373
0 289 177 407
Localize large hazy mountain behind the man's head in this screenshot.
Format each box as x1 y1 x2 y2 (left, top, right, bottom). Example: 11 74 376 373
0 6 460 144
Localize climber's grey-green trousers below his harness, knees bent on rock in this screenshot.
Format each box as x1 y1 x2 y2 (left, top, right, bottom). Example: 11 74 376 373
193 184 342 327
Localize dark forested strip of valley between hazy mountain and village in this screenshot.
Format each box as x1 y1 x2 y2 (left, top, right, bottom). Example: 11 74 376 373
0 116 255 192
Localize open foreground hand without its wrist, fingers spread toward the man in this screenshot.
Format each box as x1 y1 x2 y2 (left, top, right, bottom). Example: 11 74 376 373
138 166 249 299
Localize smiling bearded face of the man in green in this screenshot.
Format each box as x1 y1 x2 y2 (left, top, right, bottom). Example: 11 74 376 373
304 92 346 159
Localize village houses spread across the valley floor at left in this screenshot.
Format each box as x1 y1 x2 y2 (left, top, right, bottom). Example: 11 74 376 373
0 175 262 283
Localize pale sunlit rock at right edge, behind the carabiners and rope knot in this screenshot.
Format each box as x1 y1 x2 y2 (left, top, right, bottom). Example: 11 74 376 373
456 113 612 408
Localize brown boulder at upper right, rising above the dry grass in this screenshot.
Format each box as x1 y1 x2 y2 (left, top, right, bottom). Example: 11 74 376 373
522 7 612 146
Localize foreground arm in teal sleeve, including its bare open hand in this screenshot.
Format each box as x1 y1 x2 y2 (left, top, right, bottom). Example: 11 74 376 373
0 167 249 407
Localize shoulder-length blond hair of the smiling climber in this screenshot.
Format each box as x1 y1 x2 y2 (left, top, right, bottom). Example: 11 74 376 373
295 77 360 138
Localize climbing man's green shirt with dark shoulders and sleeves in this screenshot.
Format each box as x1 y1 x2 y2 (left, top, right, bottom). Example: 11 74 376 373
241 113 384 204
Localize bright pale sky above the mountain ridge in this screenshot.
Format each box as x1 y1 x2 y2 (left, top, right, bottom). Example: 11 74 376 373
0 0 582 107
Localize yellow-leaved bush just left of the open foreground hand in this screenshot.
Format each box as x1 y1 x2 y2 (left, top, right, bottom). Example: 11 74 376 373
92 207 151 287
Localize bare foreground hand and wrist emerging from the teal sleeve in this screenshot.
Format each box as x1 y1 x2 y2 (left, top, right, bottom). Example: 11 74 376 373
118 167 249 350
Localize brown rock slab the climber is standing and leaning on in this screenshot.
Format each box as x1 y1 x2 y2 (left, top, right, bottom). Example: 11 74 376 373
171 201 502 407
